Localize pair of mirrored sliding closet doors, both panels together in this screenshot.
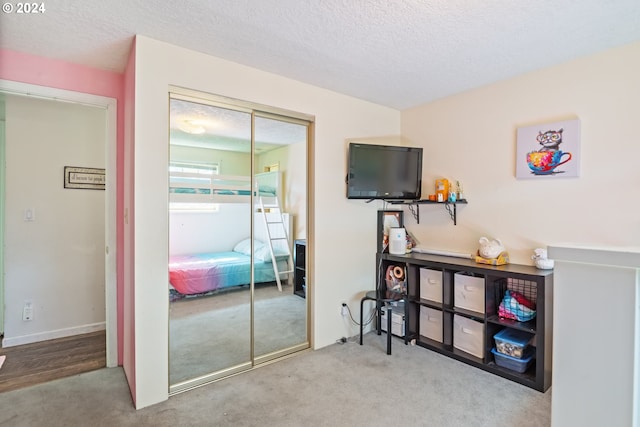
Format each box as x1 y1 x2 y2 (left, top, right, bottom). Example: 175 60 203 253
168 93 309 393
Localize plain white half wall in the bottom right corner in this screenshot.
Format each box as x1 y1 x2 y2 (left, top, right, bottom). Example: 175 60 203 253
549 246 640 427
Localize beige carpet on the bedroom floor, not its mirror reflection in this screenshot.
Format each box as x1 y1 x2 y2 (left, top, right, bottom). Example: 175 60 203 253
0 333 551 427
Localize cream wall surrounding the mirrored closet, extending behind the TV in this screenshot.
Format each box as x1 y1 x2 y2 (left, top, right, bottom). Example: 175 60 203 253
125 36 400 408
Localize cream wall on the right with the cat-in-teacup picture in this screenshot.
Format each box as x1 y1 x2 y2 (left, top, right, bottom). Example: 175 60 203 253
402 43 640 264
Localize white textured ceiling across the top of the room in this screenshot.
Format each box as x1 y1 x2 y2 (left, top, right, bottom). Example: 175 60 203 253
0 0 640 109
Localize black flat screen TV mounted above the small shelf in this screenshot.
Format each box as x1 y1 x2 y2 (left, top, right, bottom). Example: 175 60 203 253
347 142 422 200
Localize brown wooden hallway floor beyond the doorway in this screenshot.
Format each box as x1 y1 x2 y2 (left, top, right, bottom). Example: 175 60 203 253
0 331 107 393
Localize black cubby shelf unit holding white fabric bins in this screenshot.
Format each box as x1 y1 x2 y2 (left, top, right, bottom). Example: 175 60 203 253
376 253 553 392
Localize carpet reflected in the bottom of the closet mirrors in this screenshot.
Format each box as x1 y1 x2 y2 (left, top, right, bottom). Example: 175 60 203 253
169 285 307 384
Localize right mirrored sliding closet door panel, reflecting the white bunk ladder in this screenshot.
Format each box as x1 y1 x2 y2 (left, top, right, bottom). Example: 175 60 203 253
253 113 308 362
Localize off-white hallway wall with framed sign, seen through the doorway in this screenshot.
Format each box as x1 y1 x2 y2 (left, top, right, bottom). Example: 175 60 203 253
3 96 106 346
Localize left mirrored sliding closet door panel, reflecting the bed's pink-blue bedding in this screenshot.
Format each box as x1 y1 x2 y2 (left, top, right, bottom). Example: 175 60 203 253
169 98 252 387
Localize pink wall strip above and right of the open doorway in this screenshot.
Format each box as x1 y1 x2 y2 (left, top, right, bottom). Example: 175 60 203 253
0 49 124 365
